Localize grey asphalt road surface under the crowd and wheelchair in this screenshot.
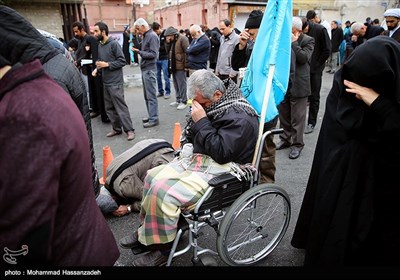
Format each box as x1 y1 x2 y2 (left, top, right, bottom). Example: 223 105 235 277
92 66 333 267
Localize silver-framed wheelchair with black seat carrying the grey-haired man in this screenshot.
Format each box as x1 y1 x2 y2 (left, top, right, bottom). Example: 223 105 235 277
132 129 291 266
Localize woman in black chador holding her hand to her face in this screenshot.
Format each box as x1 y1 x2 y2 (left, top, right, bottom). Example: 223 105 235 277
291 36 400 266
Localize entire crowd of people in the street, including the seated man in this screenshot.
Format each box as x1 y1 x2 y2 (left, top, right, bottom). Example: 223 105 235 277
0 1 400 266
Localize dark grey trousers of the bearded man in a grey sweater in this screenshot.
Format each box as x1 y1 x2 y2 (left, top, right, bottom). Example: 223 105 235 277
104 85 135 132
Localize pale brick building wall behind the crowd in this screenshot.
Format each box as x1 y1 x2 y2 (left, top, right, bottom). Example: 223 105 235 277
0 0 399 41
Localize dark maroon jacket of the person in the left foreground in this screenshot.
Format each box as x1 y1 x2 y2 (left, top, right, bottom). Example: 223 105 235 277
0 59 119 267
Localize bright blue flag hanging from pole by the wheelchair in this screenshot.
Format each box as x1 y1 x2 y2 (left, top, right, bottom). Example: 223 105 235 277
241 0 293 122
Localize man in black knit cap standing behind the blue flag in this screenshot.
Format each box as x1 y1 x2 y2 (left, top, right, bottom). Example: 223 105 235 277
232 10 278 183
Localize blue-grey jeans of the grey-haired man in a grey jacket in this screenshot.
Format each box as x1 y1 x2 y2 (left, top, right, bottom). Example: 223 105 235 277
142 70 158 122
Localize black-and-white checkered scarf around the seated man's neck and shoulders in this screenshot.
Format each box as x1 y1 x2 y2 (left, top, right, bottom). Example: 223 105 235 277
205 78 258 120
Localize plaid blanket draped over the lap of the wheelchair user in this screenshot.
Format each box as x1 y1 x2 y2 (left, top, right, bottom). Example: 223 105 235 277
138 154 237 246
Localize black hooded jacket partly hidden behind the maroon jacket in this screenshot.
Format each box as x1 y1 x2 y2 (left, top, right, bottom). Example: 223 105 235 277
0 6 100 194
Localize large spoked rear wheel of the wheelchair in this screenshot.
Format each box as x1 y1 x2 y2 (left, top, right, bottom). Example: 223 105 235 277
217 184 291 266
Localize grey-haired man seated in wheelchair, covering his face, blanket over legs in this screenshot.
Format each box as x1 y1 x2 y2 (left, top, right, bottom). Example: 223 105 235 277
120 69 258 266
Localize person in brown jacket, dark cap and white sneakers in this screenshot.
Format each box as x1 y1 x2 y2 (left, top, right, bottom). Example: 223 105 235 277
164 26 189 108
